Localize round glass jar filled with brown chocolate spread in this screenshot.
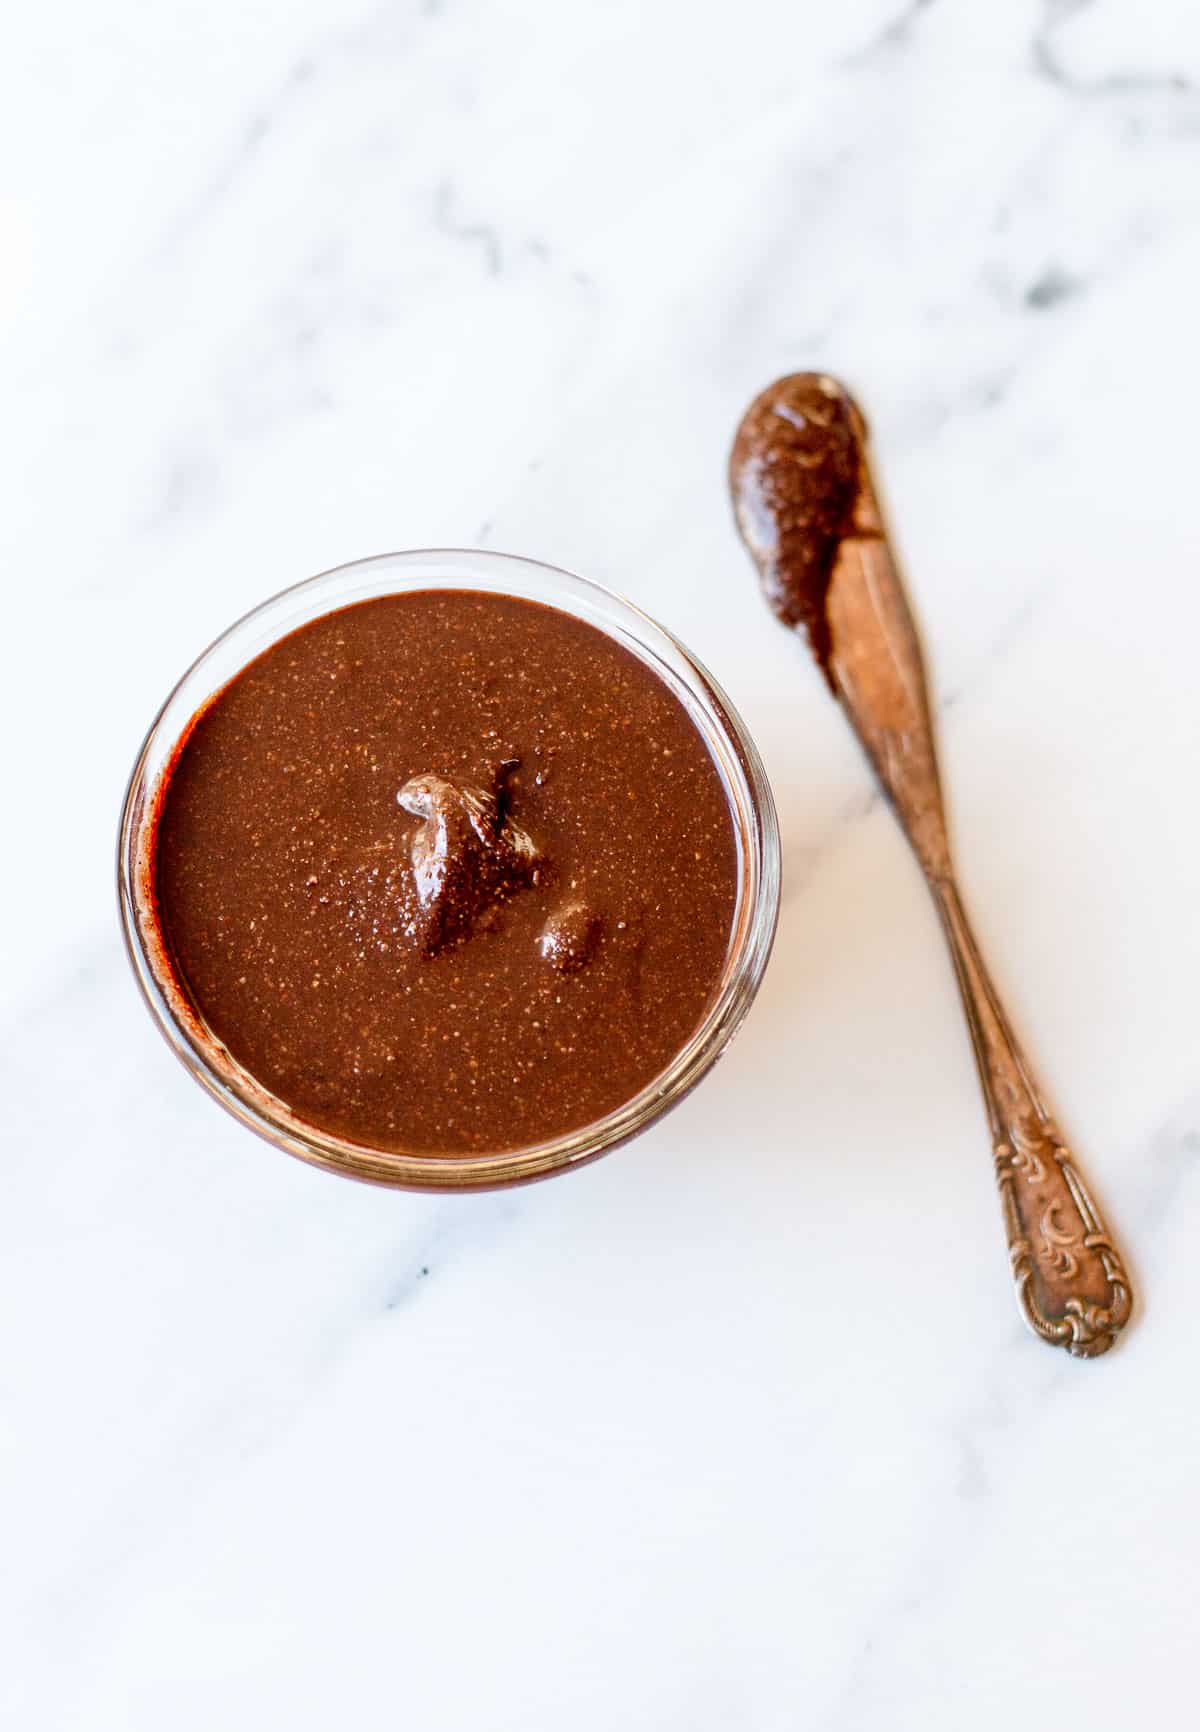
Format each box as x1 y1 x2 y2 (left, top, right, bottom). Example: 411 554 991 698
118 551 779 1190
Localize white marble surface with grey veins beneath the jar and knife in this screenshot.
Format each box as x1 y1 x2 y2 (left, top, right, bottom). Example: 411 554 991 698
0 0 1200 1732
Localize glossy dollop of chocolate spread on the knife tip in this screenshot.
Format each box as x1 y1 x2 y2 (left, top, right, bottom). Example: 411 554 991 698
729 372 866 686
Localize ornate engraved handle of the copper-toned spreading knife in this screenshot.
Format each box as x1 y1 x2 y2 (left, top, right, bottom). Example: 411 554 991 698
933 878 1132 1358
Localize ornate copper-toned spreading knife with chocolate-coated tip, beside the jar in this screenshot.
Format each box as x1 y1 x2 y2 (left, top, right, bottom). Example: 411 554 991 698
729 372 1132 1358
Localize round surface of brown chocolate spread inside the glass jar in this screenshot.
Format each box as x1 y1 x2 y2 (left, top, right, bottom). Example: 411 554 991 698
152 591 738 1155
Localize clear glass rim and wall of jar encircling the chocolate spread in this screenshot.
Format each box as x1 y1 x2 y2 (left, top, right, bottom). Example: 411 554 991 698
118 549 779 1190
